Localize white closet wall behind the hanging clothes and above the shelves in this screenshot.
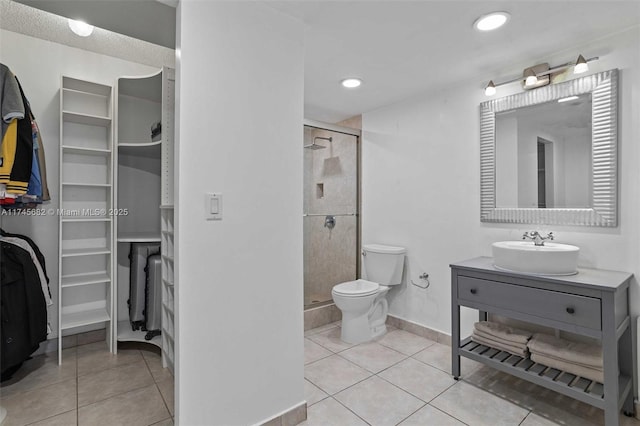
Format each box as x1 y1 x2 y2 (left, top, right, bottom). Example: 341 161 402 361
0 30 165 339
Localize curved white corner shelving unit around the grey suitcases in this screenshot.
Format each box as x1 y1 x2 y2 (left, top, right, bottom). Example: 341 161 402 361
113 68 175 372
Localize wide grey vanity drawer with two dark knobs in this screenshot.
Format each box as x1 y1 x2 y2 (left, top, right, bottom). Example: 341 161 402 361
458 276 602 330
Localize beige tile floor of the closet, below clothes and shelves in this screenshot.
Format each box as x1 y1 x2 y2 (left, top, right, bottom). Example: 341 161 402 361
0 342 173 426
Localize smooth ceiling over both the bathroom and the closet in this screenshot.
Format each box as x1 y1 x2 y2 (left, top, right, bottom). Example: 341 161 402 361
10 0 640 122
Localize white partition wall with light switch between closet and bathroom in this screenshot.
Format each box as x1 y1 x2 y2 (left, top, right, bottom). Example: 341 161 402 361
176 1 304 425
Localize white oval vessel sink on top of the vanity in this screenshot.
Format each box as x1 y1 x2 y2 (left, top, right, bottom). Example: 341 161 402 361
491 241 580 275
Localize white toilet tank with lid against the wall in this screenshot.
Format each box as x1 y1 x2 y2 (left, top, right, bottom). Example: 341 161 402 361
362 244 407 285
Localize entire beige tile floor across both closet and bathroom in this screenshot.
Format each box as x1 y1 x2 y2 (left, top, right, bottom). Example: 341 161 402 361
5 323 640 426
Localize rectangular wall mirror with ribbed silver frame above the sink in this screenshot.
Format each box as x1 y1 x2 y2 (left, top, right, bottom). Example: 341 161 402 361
480 69 618 226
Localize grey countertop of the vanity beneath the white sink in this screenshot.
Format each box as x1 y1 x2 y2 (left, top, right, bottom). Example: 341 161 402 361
450 256 633 291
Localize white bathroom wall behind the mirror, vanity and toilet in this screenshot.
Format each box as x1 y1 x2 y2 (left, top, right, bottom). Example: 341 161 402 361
362 28 640 344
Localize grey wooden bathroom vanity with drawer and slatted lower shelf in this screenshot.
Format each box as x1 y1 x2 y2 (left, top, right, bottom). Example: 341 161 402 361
450 257 633 426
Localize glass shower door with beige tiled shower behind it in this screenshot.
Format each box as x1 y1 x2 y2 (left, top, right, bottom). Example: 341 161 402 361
303 126 359 309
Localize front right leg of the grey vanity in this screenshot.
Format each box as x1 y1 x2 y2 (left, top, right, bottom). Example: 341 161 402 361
602 293 620 426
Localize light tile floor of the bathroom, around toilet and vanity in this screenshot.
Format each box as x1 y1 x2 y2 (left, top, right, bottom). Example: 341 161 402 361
302 323 640 426
